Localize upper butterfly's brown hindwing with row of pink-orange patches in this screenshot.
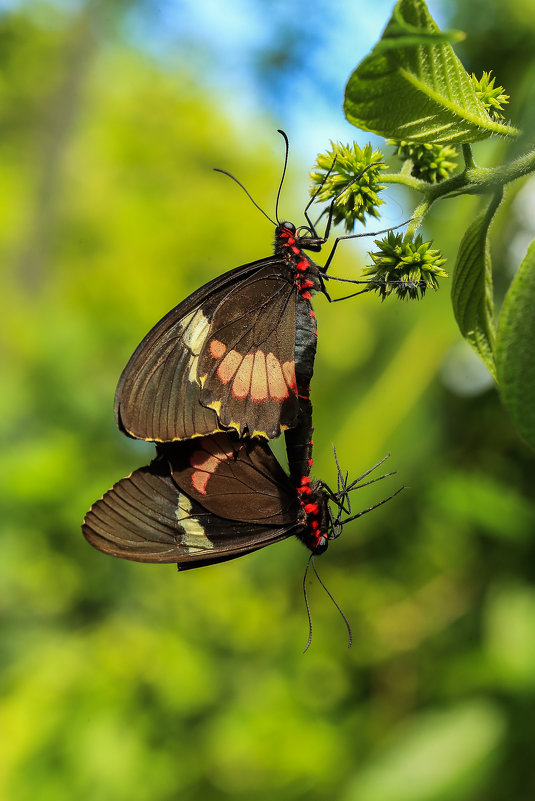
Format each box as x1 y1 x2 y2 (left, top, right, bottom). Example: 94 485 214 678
199 262 298 439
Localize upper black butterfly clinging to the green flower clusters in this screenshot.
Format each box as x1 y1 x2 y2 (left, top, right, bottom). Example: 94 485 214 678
115 131 398 442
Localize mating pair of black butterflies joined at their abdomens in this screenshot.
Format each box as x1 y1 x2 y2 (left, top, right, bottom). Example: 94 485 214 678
83 131 398 569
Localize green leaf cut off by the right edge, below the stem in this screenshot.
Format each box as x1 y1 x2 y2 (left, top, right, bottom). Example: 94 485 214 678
496 242 535 449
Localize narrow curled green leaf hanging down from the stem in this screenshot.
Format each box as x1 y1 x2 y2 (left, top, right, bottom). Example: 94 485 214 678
451 190 502 379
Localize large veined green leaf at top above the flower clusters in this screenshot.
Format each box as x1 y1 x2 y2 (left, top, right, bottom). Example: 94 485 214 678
344 0 518 143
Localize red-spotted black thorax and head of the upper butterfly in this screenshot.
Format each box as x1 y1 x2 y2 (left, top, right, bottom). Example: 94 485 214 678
274 222 323 300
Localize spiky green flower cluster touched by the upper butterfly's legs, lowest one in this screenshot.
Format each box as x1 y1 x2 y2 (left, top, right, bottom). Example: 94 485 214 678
363 231 448 300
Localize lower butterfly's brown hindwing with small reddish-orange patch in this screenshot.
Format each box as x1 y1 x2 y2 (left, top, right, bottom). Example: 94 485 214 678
161 434 299 526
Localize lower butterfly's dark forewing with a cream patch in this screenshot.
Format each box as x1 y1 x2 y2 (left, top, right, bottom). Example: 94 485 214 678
82 458 295 570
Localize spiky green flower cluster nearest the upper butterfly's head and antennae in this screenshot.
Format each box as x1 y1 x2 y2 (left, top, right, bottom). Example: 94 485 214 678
310 142 386 233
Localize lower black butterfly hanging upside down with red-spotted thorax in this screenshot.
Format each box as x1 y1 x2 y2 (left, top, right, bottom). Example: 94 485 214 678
82 432 399 570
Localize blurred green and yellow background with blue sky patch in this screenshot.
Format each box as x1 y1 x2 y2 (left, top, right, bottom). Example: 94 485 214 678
0 0 535 801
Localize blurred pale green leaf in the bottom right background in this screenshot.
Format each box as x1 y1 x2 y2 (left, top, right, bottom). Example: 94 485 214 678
343 701 505 801
